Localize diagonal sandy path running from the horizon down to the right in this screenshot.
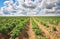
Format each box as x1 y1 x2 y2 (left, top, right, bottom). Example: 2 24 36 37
32 18 55 39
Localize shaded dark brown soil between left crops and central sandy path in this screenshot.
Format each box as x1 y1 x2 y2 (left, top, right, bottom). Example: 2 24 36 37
15 22 30 39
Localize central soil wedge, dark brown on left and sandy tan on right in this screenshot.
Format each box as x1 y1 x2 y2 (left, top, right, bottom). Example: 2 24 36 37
9 19 36 39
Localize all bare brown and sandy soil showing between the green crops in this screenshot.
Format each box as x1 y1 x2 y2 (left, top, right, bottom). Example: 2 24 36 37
0 17 60 39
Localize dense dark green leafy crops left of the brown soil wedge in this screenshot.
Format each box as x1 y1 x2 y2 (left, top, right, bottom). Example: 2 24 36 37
0 17 29 39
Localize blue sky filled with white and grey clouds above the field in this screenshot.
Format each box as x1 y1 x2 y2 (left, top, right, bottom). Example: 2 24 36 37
0 0 60 16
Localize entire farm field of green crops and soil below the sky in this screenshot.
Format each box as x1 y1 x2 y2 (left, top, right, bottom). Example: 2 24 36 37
0 16 60 39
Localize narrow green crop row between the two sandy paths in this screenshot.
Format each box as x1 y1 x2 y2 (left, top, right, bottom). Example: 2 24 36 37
32 20 47 39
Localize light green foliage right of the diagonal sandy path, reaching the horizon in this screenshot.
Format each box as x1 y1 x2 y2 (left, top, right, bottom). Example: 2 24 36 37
35 16 60 28
